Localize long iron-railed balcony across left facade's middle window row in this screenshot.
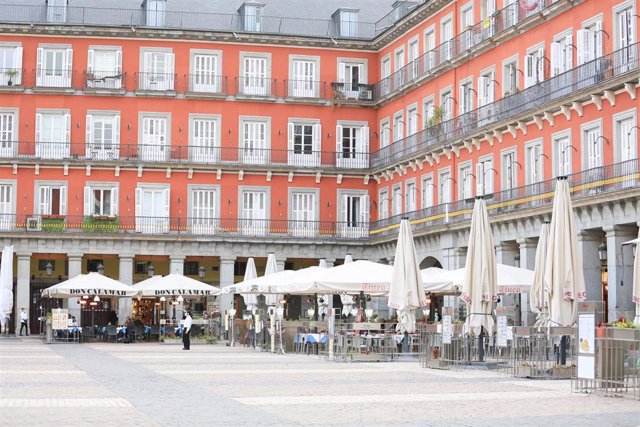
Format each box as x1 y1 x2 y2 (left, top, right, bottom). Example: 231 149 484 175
0 141 369 170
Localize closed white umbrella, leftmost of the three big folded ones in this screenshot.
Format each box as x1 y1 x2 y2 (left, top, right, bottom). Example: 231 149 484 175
387 219 427 333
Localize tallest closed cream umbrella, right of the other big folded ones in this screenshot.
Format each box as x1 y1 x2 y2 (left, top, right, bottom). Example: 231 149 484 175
544 179 586 326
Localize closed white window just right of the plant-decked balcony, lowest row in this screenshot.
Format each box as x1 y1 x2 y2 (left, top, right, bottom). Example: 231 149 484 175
135 184 171 234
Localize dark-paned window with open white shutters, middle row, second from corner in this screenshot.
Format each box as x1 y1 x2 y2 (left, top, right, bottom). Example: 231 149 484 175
288 120 322 166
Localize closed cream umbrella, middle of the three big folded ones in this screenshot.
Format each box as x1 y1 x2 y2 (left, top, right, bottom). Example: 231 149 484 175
460 198 498 335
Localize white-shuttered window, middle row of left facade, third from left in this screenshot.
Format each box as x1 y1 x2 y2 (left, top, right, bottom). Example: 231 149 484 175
85 112 120 160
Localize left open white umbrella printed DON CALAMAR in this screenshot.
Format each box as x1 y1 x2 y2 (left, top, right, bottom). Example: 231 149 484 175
42 273 140 298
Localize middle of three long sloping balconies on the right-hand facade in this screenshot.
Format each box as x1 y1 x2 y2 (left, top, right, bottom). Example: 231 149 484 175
371 44 640 169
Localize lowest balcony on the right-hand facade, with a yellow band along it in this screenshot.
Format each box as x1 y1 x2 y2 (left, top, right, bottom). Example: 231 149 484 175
370 159 640 237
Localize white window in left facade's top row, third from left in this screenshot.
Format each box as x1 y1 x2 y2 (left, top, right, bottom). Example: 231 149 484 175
86 46 122 89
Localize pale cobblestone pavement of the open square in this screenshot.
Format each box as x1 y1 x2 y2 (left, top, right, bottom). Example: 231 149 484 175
0 338 640 427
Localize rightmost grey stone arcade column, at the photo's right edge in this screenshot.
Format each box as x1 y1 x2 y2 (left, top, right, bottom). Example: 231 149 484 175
604 225 637 321
